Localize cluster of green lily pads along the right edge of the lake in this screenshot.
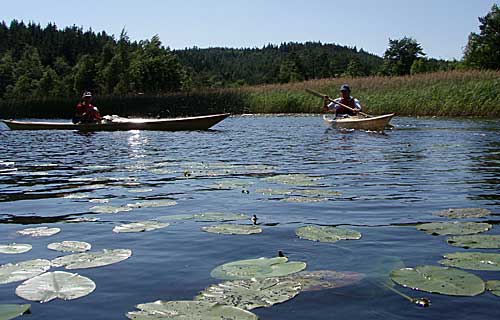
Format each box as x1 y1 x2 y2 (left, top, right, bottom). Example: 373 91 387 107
391 208 500 296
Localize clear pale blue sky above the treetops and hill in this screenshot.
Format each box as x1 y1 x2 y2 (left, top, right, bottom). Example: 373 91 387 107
0 0 500 59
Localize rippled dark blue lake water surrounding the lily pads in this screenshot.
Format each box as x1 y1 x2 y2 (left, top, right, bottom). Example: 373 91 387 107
0 116 500 320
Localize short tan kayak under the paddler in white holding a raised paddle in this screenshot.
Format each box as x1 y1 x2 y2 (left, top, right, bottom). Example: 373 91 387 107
323 113 394 131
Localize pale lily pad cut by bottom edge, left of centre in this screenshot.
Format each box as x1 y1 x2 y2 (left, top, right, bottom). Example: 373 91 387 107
126 300 258 320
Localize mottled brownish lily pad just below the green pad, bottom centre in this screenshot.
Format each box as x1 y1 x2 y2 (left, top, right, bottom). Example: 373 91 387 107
195 278 301 310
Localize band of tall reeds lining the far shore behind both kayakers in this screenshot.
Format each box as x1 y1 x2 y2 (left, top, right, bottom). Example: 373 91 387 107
0 70 500 119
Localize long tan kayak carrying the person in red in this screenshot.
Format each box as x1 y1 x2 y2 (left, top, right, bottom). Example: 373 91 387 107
1 113 230 131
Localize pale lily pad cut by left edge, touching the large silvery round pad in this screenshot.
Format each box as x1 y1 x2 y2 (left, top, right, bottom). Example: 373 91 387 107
0 259 50 284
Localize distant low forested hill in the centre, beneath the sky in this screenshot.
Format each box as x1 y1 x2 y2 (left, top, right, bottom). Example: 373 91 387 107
174 42 383 87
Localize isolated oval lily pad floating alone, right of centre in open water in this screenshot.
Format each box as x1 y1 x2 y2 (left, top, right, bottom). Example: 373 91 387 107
295 226 361 242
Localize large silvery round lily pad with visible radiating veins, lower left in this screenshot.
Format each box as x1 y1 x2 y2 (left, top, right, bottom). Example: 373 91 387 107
16 271 95 303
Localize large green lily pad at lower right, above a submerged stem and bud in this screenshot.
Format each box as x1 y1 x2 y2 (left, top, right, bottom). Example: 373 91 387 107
391 266 484 296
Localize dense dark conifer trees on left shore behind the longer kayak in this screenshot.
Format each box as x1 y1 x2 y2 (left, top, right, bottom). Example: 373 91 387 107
0 20 189 99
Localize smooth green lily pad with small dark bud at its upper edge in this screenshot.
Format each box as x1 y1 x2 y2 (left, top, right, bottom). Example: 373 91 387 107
210 257 306 280
